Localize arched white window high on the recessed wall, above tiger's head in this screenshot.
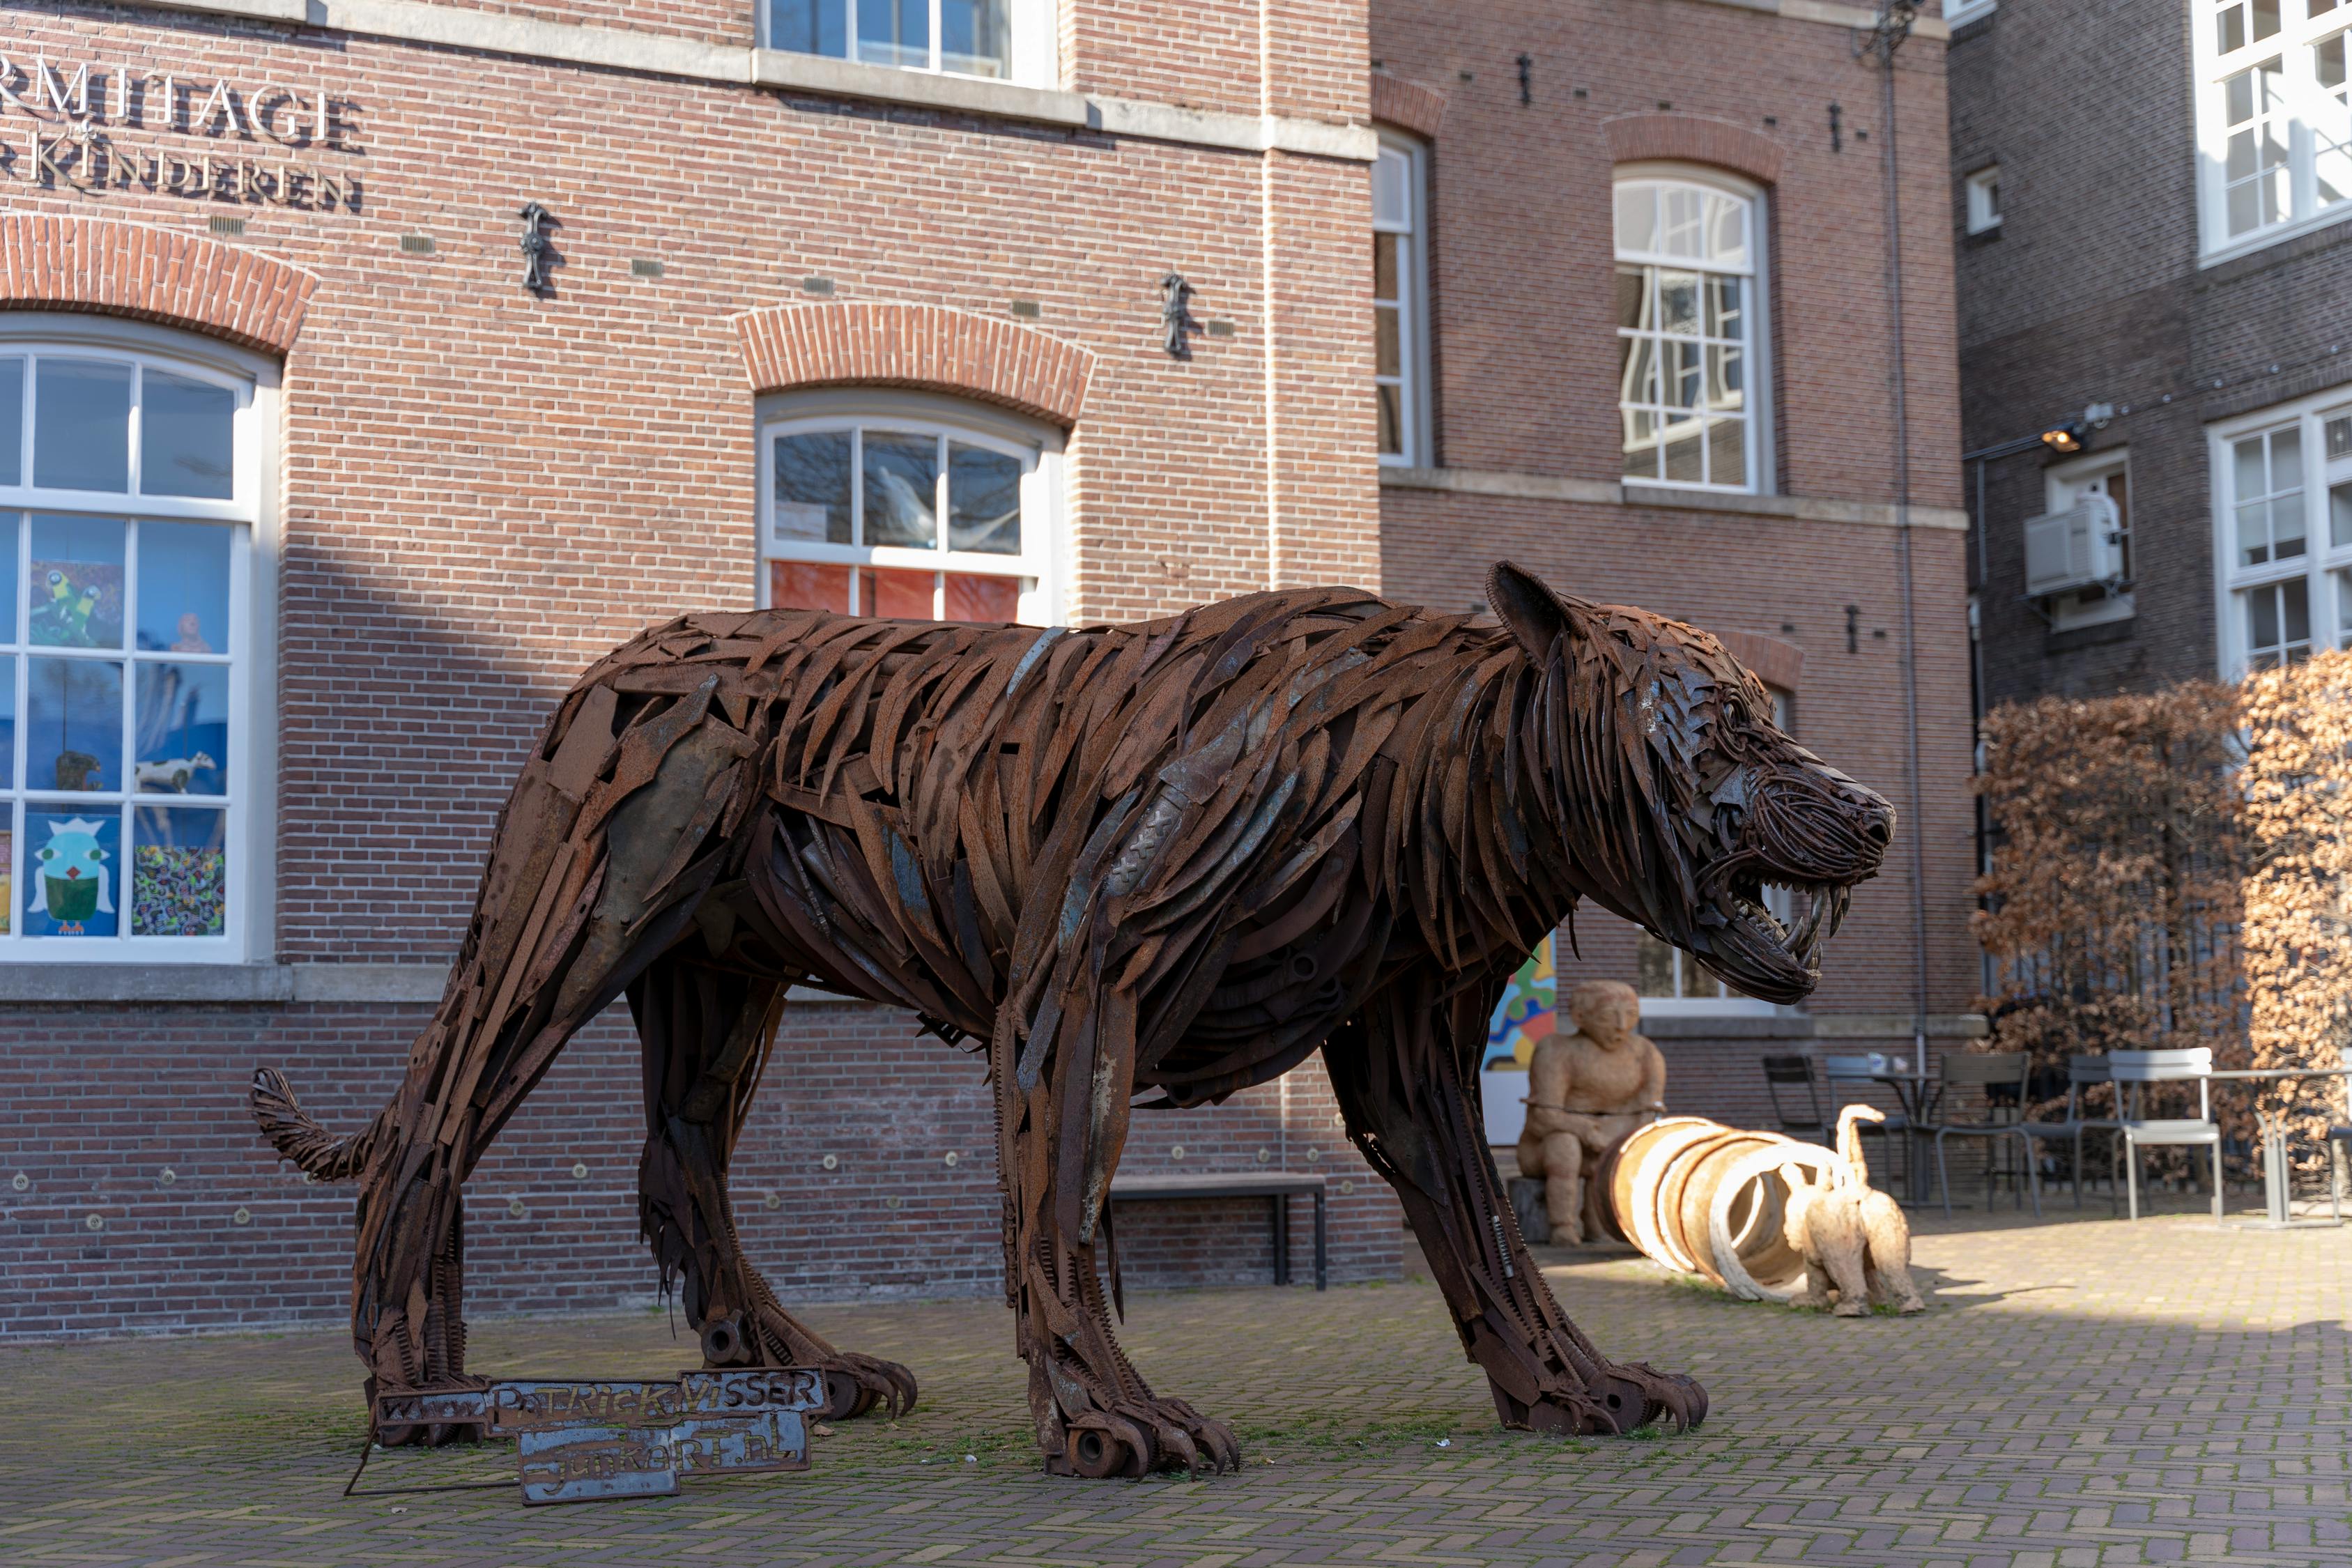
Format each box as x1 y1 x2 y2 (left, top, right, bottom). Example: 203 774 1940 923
1616 167 1771 491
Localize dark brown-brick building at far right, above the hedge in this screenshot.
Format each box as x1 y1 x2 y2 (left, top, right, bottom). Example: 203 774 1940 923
1950 0 2352 705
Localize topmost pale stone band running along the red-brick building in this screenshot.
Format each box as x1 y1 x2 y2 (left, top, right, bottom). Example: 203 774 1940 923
127 0 1952 162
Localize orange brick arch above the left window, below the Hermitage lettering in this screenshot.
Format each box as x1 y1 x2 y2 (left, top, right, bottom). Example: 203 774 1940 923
0 212 318 355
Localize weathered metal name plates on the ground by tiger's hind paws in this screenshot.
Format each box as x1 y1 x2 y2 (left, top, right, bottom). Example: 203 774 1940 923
371 1368 826 1502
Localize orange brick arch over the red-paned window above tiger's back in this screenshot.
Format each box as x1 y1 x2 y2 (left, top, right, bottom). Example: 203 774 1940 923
734 303 1093 428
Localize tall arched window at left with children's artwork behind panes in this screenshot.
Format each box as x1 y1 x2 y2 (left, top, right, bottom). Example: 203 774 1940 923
0 315 275 962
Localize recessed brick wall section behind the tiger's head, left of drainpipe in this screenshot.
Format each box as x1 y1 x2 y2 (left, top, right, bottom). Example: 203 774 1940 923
1371 0 1981 1126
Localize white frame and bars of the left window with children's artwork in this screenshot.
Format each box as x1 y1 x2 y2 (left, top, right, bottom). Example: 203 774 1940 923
0 313 280 966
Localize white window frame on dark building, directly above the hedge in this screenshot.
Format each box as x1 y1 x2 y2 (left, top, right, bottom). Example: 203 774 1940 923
2206 388 2352 682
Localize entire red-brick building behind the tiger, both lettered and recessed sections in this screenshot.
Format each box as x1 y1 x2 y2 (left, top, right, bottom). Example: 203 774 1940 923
0 0 1971 1333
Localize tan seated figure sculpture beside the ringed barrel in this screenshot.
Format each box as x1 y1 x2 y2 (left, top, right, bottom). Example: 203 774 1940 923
1519 981 1666 1243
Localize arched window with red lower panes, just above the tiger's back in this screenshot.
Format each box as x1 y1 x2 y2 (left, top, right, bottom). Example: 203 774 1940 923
760 388 1061 625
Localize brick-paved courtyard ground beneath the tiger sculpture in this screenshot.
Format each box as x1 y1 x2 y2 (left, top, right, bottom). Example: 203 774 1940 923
0 1204 2352 1568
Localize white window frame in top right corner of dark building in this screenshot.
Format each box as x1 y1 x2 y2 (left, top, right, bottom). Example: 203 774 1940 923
2190 0 2352 266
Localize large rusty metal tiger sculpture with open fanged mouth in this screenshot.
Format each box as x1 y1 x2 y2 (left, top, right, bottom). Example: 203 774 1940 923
254 564 1893 1476
